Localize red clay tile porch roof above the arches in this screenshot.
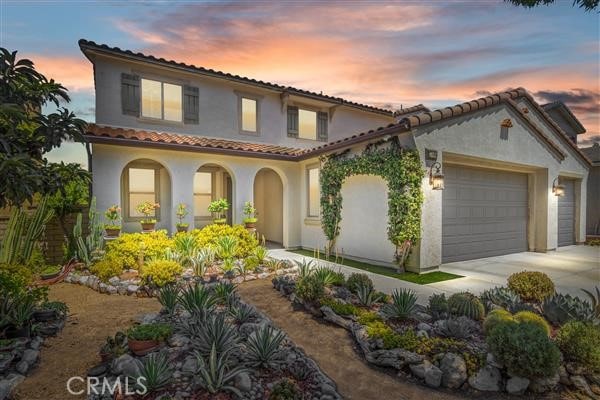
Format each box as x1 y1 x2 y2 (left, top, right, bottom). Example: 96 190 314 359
86 124 302 159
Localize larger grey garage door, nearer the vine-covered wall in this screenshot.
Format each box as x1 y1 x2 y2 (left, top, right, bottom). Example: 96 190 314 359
442 165 527 263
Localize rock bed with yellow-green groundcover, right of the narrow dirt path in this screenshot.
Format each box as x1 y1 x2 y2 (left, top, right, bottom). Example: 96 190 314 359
273 265 600 399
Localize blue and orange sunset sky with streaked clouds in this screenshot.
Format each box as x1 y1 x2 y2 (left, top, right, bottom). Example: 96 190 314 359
0 0 600 166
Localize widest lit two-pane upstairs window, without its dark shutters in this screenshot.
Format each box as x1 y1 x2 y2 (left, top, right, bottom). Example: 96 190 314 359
141 79 183 122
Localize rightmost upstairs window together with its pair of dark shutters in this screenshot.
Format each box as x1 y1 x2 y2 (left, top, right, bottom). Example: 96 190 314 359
287 106 329 142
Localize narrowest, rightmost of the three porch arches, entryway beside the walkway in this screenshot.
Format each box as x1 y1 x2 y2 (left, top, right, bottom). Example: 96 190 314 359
254 168 283 245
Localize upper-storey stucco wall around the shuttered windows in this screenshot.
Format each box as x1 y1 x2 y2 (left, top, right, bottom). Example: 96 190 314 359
94 56 394 148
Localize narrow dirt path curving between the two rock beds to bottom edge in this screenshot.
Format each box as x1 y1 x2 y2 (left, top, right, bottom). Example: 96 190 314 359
239 280 478 400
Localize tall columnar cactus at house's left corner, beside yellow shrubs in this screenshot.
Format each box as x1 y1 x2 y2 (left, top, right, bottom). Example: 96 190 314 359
73 198 104 267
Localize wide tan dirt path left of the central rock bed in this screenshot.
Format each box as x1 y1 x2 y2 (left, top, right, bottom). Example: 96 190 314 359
15 283 160 400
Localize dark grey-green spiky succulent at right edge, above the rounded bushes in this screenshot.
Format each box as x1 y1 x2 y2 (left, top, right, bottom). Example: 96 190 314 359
542 293 595 325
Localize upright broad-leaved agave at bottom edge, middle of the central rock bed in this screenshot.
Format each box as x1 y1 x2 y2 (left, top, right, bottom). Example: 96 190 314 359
196 345 248 398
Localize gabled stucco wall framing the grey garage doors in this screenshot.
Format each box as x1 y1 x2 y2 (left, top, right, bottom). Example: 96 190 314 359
411 105 588 270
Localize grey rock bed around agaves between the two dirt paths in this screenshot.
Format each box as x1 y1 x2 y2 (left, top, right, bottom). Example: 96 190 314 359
88 280 342 400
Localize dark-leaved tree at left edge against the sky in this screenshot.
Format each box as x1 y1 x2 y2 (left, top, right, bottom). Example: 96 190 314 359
0 48 90 207
